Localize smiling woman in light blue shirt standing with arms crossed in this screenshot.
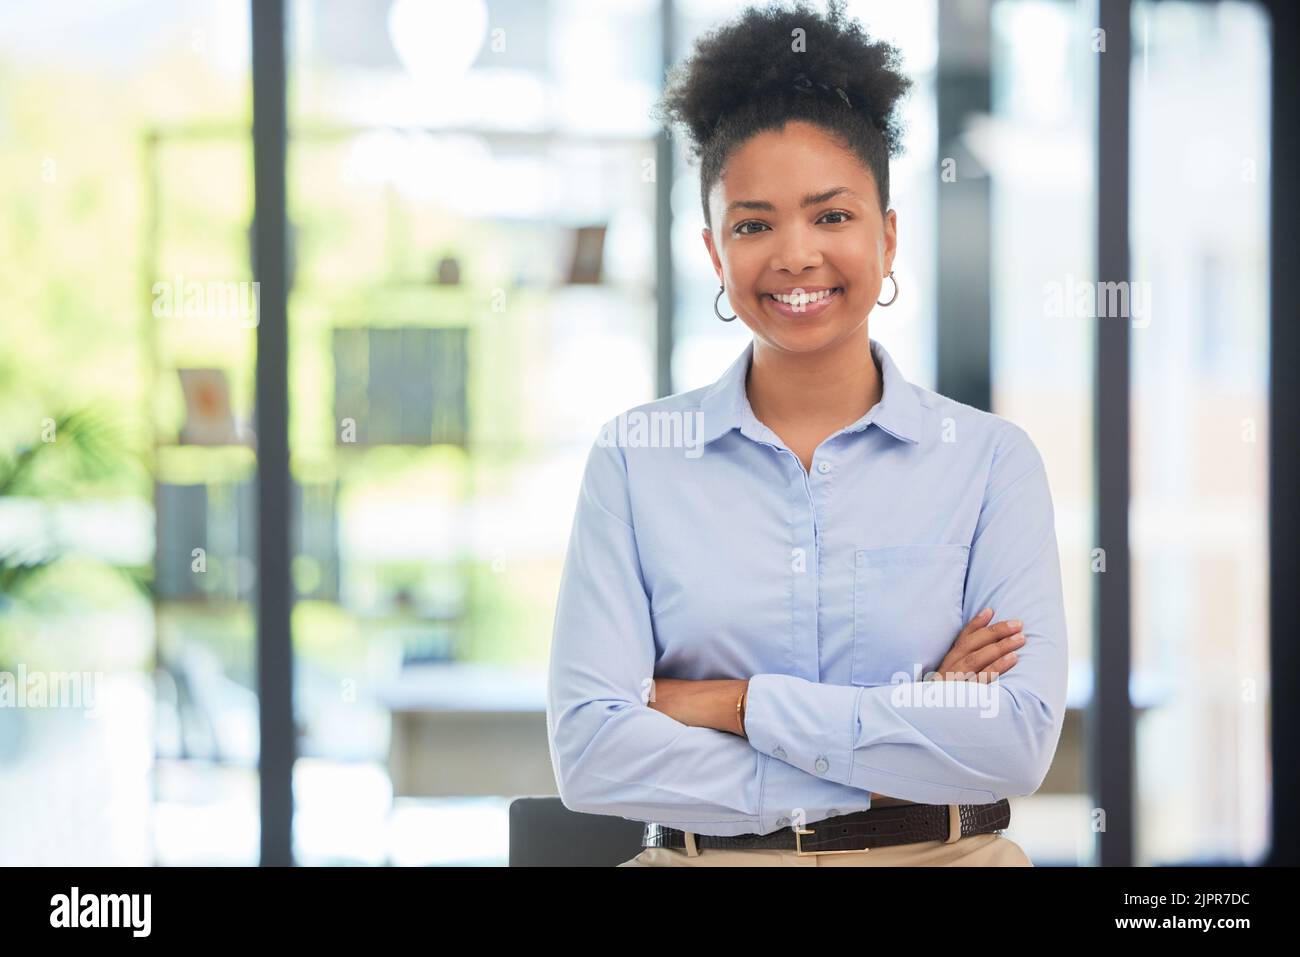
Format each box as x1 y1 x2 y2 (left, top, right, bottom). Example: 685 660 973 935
547 4 1067 866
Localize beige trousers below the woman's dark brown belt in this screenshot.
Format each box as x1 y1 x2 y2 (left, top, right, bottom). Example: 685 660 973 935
619 794 1034 867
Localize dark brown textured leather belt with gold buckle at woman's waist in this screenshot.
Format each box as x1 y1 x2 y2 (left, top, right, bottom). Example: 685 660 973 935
641 797 1011 856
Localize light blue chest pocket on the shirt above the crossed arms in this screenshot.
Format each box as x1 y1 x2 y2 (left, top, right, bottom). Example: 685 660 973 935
853 545 970 685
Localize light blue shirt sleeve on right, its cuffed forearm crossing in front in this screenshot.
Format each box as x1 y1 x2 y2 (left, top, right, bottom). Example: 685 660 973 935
745 423 1069 804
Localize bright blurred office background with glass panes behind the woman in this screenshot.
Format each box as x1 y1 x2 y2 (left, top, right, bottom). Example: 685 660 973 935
0 0 1274 865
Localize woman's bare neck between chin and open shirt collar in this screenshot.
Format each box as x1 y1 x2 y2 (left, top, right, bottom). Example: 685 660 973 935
745 334 884 429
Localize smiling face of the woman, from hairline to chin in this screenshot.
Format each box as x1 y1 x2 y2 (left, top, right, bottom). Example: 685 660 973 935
703 121 897 352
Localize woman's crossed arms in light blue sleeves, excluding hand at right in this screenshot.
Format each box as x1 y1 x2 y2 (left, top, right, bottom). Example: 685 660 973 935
547 423 1067 833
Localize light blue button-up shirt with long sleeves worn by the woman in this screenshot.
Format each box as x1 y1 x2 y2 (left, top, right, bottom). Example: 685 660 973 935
546 339 1067 835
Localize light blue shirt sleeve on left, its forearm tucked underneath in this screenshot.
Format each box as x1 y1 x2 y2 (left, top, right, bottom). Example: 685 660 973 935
546 421 767 835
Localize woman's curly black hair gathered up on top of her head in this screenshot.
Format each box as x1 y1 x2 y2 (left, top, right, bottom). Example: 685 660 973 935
651 0 911 229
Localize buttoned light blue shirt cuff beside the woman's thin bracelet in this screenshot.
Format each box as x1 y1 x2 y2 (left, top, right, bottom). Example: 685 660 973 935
745 675 865 784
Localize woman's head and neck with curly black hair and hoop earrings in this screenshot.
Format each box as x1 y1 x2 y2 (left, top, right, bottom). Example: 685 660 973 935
657 3 911 468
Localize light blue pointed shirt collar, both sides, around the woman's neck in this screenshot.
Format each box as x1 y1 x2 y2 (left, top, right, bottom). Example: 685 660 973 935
699 337 923 445
